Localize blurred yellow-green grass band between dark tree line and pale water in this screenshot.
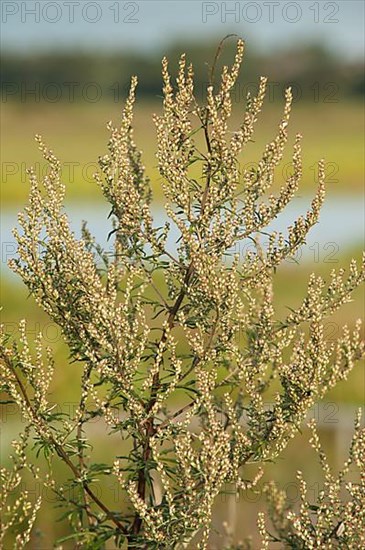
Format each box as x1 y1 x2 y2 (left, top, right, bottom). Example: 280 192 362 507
1 101 364 205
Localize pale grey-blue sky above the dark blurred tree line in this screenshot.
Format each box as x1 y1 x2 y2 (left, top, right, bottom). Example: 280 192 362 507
1 0 365 59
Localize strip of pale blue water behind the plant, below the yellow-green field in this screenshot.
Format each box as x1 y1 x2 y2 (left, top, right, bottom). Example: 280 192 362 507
0 195 365 275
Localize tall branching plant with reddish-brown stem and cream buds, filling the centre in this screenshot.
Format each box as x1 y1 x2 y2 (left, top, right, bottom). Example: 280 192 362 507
0 36 365 549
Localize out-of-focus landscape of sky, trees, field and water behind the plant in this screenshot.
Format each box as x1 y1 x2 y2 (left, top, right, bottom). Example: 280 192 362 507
0 0 365 550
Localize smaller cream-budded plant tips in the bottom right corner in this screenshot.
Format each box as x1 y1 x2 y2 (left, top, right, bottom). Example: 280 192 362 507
259 410 365 550
